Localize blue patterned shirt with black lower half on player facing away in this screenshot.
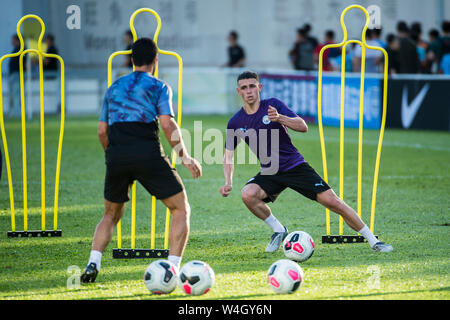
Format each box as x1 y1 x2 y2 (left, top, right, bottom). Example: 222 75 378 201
100 71 174 164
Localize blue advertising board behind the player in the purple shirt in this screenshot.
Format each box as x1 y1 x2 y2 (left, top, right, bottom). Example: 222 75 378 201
260 73 382 129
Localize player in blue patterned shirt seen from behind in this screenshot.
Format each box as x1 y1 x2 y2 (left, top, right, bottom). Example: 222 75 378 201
81 38 202 282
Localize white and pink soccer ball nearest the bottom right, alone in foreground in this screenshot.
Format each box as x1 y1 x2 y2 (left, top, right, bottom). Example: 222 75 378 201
267 259 304 293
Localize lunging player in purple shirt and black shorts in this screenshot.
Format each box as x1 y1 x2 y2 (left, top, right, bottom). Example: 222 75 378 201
220 71 393 252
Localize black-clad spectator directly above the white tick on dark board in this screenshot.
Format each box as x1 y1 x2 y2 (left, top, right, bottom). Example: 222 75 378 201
397 21 420 73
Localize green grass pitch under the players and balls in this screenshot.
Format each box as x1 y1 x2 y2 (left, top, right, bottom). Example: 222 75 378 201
0 116 450 300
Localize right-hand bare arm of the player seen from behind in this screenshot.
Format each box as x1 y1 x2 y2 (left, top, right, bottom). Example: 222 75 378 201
159 115 202 179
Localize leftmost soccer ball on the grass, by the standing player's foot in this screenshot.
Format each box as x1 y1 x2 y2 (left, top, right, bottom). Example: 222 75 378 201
144 260 179 294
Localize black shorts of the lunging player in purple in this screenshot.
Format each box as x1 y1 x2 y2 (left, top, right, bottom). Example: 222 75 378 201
246 162 330 202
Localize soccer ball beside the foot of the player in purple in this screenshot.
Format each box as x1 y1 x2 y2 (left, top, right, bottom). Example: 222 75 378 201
283 231 314 262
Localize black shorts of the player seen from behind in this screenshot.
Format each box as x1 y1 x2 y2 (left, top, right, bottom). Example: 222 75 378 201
104 156 184 203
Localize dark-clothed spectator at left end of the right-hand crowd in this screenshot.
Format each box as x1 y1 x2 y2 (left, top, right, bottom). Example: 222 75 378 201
289 29 316 71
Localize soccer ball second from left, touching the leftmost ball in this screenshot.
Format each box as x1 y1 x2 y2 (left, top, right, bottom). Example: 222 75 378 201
179 260 215 296
